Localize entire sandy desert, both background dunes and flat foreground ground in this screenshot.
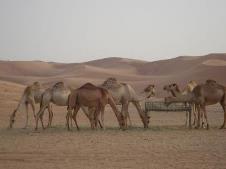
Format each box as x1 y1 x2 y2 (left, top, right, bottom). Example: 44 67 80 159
0 54 226 169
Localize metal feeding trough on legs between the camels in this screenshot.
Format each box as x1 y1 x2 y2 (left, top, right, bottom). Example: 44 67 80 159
145 101 192 128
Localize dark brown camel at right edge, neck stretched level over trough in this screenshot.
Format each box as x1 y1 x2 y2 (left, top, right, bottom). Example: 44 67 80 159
165 80 226 130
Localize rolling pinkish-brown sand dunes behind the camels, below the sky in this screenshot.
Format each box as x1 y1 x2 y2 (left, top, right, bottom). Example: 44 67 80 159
0 54 226 93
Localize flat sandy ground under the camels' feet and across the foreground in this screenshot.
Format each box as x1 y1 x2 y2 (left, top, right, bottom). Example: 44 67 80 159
0 88 226 169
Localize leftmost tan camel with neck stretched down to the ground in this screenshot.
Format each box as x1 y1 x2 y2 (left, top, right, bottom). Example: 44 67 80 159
9 82 52 128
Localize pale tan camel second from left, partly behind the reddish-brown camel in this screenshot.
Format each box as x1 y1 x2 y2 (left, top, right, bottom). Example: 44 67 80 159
35 82 98 130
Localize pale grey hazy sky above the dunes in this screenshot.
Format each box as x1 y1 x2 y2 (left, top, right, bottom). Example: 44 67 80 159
0 0 226 62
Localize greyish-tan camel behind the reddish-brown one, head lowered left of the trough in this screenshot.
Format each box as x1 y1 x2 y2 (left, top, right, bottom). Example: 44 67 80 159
101 77 150 128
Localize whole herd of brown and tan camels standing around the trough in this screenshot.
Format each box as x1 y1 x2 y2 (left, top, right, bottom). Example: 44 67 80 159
9 77 226 130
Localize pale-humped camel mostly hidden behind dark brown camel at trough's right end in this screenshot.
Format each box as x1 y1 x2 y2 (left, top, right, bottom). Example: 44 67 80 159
163 81 198 127
